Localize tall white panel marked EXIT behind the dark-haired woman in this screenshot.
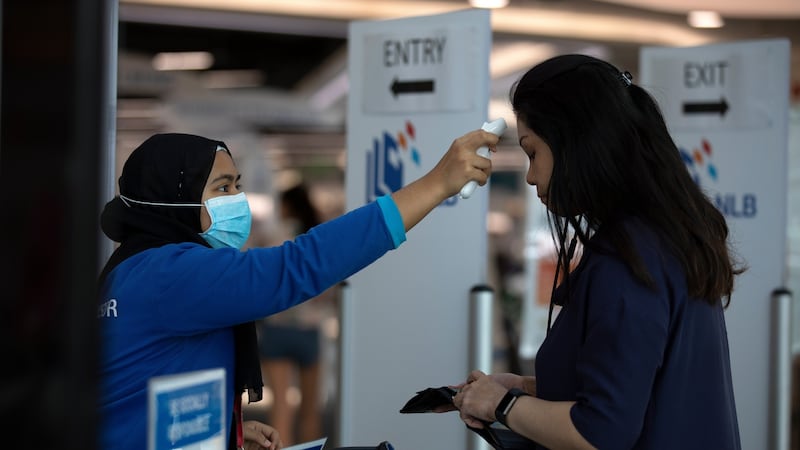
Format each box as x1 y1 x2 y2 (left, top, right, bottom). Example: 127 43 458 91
639 39 790 449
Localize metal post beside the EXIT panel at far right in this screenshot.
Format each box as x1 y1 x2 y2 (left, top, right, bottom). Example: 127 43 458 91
770 288 792 450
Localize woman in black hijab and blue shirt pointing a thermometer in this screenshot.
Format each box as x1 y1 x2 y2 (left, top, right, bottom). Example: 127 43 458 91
98 130 498 450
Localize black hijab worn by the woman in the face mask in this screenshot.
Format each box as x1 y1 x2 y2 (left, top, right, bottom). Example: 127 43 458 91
99 133 263 414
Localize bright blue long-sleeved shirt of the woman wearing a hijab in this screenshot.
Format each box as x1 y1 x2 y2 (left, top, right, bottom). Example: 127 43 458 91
98 196 405 450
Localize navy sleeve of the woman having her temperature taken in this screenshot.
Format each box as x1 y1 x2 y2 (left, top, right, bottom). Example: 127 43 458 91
571 258 670 448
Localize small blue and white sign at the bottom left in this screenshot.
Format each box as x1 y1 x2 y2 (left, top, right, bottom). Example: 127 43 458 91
147 368 228 450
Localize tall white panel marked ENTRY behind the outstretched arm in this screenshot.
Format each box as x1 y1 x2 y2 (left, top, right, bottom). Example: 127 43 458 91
337 9 491 450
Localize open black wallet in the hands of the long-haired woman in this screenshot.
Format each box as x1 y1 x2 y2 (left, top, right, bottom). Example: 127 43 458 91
400 386 543 450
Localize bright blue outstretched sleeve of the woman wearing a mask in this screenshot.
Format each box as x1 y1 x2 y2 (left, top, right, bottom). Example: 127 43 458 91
132 199 404 333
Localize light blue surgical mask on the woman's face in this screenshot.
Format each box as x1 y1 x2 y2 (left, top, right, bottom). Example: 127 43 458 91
200 192 252 248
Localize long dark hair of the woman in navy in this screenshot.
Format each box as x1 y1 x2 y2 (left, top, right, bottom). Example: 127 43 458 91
510 55 745 307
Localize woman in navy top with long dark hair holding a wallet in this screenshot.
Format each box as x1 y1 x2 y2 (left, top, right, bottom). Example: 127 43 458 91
446 55 743 450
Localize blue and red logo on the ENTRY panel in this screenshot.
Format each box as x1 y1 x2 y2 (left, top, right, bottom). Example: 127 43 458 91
367 121 421 203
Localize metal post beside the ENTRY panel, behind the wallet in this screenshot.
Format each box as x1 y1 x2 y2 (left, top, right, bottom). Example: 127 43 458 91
467 285 494 450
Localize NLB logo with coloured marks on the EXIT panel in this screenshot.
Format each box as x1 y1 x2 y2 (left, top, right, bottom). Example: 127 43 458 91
678 138 758 218
